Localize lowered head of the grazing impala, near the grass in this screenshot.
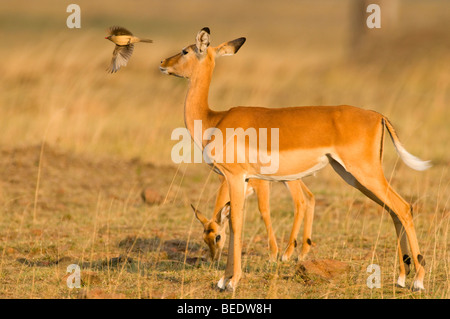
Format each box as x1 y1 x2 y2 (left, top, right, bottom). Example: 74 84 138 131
191 202 230 260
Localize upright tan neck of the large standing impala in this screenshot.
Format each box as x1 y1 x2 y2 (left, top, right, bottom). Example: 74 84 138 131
184 60 214 145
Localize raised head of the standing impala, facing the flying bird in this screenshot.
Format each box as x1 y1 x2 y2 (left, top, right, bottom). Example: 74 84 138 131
159 28 245 78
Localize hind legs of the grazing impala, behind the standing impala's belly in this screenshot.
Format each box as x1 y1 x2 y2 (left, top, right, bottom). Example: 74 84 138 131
281 180 315 261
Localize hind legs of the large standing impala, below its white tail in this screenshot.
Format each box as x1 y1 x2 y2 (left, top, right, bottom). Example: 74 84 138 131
330 157 425 290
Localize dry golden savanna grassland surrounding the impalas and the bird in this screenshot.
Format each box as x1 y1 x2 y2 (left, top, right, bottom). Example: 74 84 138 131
0 0 450 298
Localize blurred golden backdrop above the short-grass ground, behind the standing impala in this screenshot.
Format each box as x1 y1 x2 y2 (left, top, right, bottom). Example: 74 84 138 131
0 0 450 163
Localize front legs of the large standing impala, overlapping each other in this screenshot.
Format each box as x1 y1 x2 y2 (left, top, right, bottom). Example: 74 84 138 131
217 176 246 290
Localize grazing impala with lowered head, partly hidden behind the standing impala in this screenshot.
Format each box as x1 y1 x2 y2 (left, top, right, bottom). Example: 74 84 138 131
192 177 315 261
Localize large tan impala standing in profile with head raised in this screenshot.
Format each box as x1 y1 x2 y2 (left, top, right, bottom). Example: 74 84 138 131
160 28 430 290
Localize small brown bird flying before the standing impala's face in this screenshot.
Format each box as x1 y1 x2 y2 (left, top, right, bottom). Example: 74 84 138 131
105 26 153 73
